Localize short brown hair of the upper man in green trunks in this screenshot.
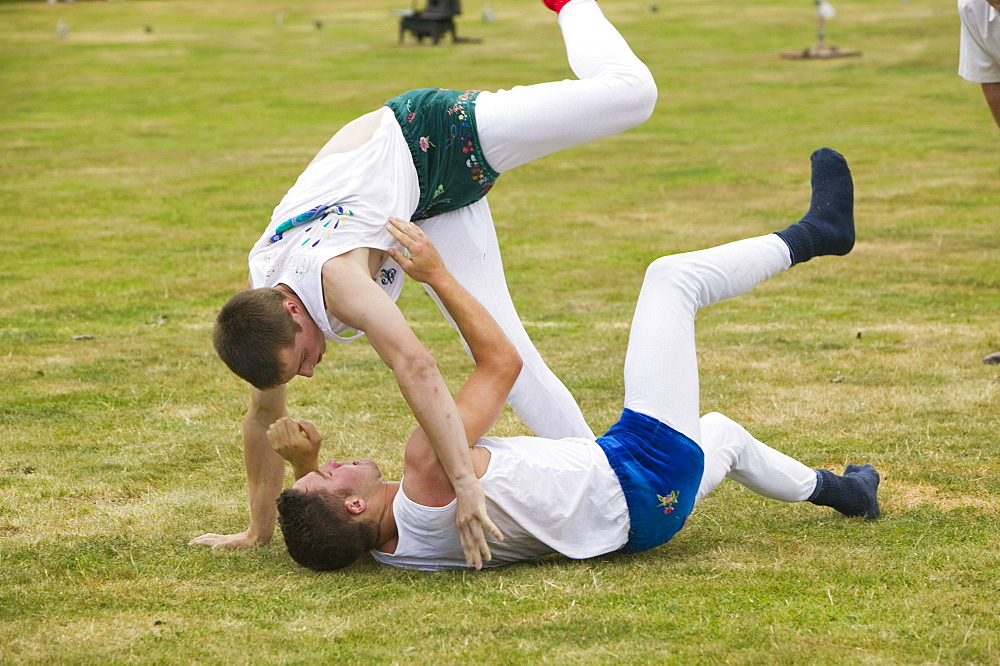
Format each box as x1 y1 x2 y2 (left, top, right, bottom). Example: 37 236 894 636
212 288 302 391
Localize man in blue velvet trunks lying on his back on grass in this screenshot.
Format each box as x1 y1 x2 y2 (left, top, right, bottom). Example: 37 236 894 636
268 148 879 570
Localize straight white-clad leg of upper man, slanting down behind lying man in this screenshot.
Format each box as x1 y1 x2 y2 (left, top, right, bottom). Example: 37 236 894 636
420 199 593 439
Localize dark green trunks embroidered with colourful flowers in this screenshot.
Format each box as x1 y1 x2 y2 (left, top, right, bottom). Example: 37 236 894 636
385 88 500 220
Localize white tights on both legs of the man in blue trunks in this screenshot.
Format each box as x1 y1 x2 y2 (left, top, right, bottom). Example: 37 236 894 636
625 234 816 502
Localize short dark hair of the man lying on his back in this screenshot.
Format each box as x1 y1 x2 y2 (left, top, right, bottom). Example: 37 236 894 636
278 488 378 571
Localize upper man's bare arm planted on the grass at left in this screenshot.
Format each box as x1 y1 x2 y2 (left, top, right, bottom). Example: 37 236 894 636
190 385 287 548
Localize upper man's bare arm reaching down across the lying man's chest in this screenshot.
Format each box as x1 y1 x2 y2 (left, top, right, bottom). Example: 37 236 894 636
323 248 502 568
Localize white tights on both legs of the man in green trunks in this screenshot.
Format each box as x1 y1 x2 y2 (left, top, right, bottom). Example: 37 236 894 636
420 0 657 438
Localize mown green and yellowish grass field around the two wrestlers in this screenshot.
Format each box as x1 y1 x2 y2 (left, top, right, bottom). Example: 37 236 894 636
0 0 1000 664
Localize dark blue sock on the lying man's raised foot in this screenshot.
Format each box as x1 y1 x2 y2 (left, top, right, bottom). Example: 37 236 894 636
775 148 854 266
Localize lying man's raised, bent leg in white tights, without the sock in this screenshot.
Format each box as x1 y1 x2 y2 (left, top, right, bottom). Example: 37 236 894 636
625 234 792 444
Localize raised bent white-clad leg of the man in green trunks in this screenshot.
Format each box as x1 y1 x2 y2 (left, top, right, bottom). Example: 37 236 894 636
476 0 657 173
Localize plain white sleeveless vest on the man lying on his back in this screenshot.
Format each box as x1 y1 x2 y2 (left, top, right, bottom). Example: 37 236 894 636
372 437 629 571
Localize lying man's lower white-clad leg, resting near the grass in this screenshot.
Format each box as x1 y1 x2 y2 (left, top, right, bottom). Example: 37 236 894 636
695 412 816 504
